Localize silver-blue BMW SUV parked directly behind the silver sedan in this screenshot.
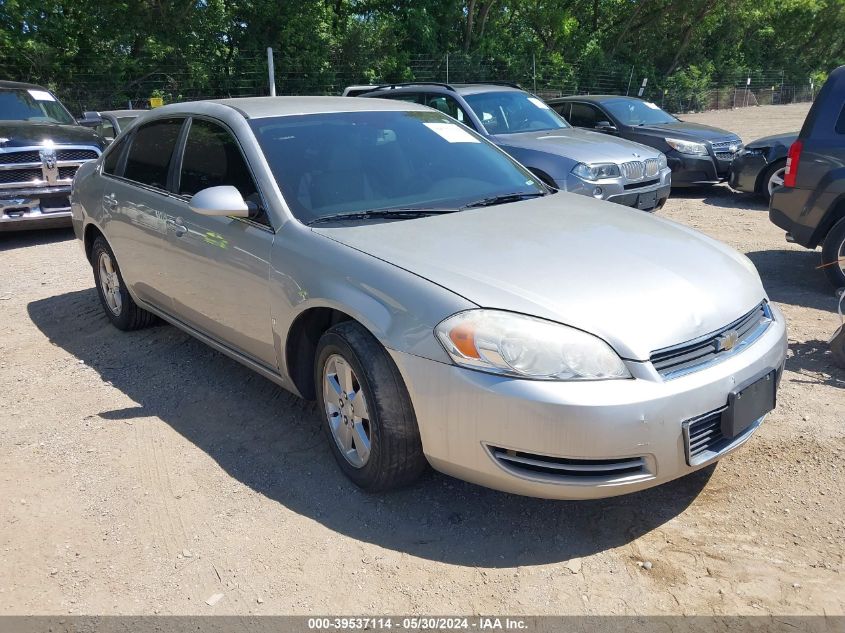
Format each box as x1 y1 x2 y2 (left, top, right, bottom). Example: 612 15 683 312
361 83 672 211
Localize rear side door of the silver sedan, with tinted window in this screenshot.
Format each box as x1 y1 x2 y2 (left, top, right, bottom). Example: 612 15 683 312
103 117 185 311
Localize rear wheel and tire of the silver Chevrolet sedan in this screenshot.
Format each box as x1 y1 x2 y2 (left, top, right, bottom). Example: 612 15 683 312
91 236 156 332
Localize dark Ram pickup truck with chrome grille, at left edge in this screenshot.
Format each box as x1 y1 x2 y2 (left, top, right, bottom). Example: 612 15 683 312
0 81 105 232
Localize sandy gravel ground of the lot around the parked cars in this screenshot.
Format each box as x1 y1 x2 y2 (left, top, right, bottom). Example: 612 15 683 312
0 106 845 614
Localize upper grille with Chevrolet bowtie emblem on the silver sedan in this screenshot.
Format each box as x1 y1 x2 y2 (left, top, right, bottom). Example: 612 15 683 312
650 301 772 379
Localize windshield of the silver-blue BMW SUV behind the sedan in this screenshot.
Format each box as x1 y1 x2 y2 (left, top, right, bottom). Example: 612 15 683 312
464 92 569 134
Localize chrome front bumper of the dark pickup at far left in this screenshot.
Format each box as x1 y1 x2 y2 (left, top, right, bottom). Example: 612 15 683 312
0 187 71 232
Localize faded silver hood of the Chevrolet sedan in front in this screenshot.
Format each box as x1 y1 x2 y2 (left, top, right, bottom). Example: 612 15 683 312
312 193 765 360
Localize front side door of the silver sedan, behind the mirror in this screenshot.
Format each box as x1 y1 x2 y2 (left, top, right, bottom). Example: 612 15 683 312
160 117 277 371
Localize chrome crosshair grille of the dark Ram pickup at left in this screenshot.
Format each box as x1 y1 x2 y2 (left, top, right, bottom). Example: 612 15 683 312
0 145 100 191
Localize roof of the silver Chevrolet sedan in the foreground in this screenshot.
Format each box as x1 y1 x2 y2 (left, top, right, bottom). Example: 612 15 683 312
148 97 430 119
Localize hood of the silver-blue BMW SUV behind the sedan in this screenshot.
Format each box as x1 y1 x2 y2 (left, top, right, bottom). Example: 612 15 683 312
492 128 659 163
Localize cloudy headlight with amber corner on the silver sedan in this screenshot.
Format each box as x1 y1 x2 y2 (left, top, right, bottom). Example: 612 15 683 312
435 310 631 380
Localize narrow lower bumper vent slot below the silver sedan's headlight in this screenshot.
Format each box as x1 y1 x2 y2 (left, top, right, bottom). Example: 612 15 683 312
487 446 651 482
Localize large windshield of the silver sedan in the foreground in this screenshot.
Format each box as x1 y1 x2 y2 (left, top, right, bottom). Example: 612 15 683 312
250 111 546 223
